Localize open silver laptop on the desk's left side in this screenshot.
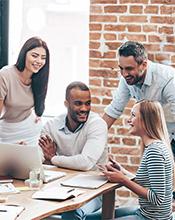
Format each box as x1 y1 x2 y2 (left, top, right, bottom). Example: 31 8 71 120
0 143 66 183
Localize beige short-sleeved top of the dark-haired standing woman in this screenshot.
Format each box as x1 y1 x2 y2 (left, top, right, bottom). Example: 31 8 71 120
0 66 34 123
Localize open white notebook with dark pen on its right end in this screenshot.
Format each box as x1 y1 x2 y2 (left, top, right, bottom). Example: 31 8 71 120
32 186 84 200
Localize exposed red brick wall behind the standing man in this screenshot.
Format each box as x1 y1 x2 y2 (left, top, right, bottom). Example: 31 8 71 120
89 0 175 203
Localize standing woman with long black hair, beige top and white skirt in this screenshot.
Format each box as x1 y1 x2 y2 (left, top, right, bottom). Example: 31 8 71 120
0 37 50 144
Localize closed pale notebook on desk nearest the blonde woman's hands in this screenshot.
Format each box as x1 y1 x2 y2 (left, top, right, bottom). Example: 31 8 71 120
61 174 108 189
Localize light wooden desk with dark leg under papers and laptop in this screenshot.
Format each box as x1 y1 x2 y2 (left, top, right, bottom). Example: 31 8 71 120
6 169 118 220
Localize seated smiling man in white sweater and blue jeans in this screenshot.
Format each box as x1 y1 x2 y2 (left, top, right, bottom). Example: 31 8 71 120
39 82 107 220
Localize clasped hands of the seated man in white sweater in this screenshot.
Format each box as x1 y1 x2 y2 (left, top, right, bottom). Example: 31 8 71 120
39 134 57 161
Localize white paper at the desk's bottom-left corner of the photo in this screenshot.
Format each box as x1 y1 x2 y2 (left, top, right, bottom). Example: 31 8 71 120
0 205 24 220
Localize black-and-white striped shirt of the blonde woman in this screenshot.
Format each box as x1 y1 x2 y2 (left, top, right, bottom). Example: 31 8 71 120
135 141 173 220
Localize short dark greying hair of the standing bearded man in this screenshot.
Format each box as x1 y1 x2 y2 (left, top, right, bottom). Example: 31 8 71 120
118 41 147 64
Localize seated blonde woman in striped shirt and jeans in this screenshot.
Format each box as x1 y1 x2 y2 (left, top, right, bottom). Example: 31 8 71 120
104 100 173 220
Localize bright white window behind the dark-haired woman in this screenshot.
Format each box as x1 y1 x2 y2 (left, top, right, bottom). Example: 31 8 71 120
9 0 89 115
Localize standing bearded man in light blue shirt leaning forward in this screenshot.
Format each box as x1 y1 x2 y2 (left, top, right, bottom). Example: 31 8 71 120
103 41 175 199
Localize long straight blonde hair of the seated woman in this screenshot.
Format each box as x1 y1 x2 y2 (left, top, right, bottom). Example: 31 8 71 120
138 100 173 159
